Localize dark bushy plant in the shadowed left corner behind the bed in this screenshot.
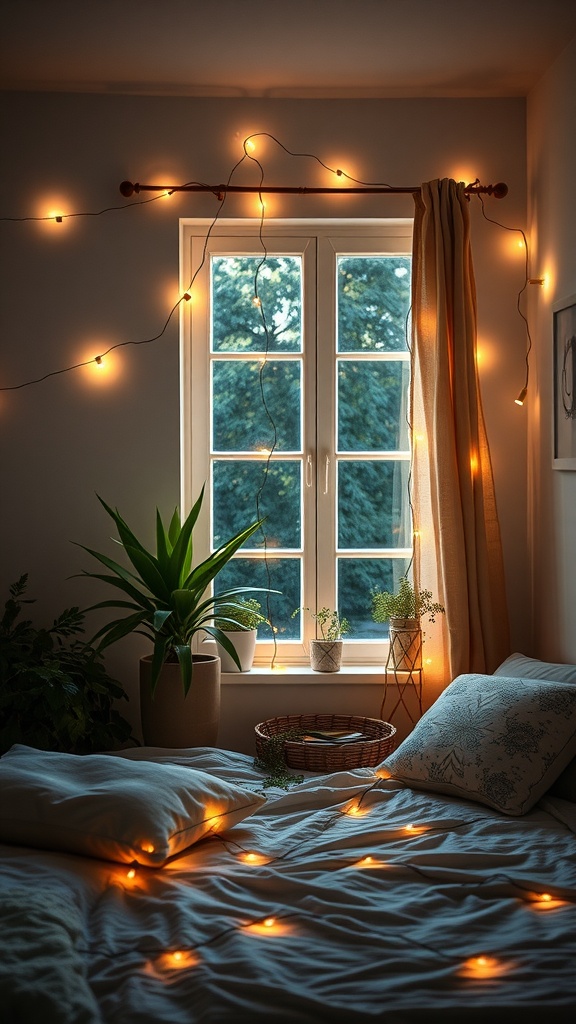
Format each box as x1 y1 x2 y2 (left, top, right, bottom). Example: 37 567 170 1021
0 573 137 754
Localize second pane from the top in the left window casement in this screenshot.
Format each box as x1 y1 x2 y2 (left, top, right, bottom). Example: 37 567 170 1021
212 359 301 452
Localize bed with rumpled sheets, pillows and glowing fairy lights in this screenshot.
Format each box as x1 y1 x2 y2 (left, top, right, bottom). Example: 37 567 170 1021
0 655 576 1024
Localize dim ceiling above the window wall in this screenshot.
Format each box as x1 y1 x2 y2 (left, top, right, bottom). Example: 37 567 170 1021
0 0 576 98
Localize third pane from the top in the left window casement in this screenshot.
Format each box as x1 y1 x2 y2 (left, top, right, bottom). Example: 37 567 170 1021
212 460 301 550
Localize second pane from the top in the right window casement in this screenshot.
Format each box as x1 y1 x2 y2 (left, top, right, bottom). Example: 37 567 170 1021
338 359 410 452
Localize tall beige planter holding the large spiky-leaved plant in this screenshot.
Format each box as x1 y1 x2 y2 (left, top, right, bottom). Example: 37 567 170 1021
140 654 220 748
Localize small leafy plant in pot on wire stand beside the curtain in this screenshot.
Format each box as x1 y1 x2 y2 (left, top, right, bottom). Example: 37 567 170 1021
372 575 444 672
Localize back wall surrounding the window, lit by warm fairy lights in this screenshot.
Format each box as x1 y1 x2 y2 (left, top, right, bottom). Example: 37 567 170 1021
0 93 528 753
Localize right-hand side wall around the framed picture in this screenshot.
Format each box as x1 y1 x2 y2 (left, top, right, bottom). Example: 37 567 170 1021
528 38 576 662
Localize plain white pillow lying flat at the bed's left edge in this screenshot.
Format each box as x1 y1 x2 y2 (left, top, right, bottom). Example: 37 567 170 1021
0 744 265 867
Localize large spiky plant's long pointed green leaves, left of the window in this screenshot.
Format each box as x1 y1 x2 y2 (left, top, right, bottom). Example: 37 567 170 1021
79 487 263 694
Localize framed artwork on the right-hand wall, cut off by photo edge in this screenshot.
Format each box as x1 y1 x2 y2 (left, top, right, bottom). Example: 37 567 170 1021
552 295 576 470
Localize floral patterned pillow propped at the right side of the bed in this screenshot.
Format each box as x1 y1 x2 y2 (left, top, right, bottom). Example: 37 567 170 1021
381 675 576 815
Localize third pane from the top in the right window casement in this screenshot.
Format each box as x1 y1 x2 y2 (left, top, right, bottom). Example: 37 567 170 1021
338 461 412 549
